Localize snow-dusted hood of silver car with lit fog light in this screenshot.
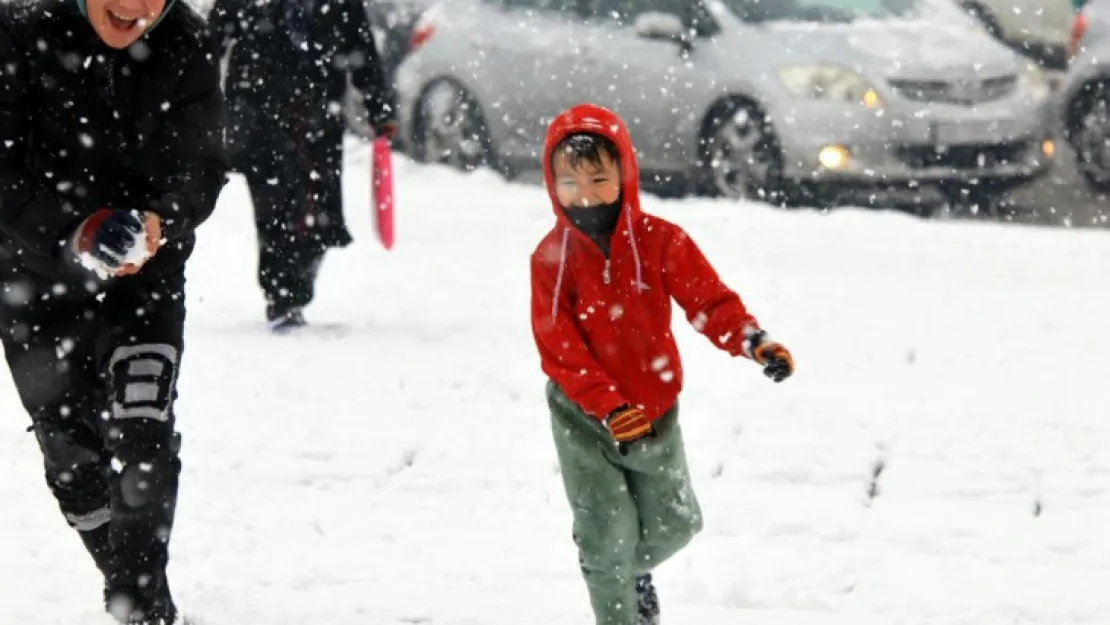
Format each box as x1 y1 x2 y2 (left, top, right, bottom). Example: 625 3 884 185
754 20 1020 80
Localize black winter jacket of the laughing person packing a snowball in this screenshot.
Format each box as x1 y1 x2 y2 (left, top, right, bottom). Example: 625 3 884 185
0 0 229 283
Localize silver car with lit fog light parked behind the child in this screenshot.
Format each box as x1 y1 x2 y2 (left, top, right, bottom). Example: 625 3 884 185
397 0 1055 203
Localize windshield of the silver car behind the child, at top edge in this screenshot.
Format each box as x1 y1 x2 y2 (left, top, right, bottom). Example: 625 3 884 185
722 0 920 23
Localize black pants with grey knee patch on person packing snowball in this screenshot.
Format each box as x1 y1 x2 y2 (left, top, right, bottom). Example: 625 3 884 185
0 264 185 604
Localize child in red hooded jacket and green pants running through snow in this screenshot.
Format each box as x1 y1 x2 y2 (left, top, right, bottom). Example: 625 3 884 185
532 104 794 625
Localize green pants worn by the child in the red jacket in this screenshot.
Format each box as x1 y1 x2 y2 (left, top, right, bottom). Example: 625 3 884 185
547 383 702 625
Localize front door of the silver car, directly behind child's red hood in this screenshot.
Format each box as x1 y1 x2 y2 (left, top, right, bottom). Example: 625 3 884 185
582 0 712 170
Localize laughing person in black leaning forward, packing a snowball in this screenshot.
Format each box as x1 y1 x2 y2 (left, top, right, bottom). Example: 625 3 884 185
0 0 229 625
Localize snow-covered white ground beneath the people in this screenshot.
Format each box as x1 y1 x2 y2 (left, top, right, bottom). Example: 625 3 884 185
0 142 1110 625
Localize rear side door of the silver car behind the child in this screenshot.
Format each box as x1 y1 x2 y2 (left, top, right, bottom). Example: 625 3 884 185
474 0 588 164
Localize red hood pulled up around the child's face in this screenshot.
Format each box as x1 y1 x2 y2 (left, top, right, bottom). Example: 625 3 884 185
544 104 639 231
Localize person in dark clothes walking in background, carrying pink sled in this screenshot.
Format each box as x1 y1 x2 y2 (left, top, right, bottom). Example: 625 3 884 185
209 0 394 331
